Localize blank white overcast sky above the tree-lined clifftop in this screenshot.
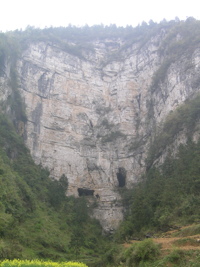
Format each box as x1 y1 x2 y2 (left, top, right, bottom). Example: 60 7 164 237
0 0 200 31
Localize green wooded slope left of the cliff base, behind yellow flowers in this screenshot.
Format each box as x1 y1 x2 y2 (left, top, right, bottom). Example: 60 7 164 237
0 115 108 260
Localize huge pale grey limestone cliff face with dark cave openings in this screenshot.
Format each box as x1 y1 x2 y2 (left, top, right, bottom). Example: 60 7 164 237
7 28 200 230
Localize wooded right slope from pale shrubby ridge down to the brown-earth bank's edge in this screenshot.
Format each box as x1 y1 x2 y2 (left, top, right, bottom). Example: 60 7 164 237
115 96 200 242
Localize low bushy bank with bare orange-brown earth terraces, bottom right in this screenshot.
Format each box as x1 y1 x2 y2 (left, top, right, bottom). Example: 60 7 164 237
99 224 200 267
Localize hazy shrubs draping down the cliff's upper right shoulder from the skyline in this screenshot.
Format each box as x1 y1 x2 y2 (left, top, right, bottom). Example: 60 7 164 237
150 18 200 92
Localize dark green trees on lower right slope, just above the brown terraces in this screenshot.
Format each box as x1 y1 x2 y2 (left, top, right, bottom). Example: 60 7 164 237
124 142 200 237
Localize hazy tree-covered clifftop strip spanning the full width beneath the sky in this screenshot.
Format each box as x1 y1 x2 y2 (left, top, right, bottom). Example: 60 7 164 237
0 18 195 61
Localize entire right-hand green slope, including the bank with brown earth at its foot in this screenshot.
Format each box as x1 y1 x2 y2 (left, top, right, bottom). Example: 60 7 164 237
101 95 200 267
